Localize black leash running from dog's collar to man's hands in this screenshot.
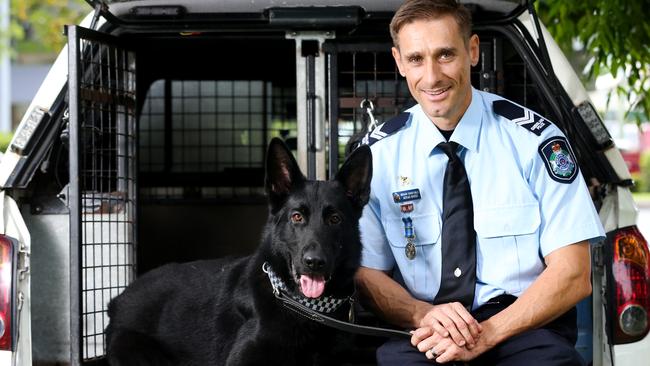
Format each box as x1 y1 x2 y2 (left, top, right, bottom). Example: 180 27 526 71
274 291 411 339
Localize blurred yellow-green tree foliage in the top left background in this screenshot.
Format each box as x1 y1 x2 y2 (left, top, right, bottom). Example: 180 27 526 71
10 0 86 53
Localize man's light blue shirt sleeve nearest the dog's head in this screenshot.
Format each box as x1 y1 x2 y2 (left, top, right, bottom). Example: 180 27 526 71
359 195 395 271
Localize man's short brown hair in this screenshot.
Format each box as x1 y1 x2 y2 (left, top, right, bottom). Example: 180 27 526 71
390 0 472 47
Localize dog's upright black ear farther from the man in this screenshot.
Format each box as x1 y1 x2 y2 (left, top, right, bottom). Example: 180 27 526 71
264 137 305 205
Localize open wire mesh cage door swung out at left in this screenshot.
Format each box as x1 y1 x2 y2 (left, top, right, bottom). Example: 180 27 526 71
68 26 137 365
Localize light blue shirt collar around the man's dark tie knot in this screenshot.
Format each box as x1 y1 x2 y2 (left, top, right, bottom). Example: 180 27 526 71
408 88 483 155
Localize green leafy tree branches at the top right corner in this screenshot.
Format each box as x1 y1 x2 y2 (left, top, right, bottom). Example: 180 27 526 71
536 0 650 123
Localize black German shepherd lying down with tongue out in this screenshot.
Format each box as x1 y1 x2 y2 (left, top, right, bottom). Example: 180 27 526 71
106 139 372 366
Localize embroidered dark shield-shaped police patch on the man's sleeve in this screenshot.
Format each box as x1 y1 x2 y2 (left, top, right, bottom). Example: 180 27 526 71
539 136 578 183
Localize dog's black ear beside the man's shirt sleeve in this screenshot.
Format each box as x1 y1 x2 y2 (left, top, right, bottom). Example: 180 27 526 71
336 145 372 210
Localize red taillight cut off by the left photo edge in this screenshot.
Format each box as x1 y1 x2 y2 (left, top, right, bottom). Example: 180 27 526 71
0 235 16 351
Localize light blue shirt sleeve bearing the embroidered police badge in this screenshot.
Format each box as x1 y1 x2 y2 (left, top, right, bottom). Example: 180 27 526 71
529 126 605 257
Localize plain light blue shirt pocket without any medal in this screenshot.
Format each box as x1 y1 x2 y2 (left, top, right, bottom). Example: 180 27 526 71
474 202 541 295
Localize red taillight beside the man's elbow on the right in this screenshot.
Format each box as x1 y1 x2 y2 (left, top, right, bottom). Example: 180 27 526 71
610 226 650 344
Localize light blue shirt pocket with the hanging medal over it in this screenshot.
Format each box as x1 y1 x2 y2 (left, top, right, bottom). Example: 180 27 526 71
383 213 441 300
